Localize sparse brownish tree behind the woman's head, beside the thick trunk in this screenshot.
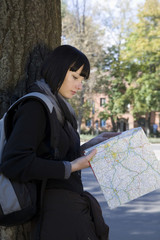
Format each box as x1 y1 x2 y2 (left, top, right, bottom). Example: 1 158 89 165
62 0 103 132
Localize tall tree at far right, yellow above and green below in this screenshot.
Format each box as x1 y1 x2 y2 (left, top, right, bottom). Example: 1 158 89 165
121 0 160 132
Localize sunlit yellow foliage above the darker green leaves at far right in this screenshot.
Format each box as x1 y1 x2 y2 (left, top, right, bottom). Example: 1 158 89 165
124 0 160 62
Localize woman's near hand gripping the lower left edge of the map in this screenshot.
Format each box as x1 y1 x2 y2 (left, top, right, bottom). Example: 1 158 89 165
71 149 97 172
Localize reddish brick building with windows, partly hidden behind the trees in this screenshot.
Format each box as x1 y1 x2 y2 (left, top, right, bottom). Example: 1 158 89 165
81 93 160 133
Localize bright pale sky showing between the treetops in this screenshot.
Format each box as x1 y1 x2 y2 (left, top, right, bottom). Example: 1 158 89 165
66 0 146 47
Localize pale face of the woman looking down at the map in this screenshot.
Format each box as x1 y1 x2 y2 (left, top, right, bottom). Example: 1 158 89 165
59 66 84 99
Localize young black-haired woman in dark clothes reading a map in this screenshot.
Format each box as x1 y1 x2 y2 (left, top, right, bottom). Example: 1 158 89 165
2 45 116 240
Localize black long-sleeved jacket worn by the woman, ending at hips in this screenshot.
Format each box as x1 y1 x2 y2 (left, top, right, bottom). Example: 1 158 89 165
2 96 83 192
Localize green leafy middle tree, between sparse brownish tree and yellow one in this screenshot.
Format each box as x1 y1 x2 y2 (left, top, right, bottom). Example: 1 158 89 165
95 46 128 130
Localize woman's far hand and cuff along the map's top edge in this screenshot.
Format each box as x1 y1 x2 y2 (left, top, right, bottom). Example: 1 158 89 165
81 132 121 153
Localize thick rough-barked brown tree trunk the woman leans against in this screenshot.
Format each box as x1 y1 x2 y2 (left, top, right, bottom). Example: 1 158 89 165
0 0 61 240
